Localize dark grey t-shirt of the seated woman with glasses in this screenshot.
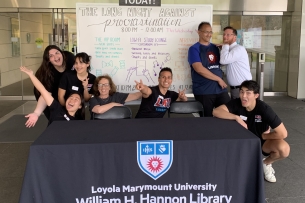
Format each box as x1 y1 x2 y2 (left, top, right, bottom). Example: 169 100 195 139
89 92 129 113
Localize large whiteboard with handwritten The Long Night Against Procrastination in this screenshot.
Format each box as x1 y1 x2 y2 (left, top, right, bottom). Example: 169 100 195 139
76 3 213 93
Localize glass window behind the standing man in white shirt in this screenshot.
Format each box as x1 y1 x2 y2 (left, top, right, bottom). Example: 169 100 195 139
212 15 289 92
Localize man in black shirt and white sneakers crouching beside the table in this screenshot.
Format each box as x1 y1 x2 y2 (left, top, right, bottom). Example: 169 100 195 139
213 80 290 183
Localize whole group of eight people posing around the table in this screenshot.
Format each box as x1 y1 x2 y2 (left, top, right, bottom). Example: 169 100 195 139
20 22 290 182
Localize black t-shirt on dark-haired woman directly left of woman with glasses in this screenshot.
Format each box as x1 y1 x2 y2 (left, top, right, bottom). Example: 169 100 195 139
58 71 95 100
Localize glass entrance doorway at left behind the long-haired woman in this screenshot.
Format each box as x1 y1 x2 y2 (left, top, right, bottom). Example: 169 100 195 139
0 9 76 100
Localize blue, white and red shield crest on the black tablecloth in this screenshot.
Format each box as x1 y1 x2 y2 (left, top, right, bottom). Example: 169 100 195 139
137 140 173 180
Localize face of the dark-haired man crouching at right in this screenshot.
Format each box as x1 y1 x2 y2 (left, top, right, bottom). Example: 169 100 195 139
239 87 259 111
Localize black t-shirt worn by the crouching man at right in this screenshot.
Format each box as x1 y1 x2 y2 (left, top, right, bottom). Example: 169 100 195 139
225 98 282 140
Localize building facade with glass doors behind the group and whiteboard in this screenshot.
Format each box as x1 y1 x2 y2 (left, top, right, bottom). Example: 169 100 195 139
0 0 305 100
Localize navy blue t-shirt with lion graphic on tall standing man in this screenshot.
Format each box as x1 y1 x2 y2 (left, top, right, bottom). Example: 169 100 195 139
188 42 227 95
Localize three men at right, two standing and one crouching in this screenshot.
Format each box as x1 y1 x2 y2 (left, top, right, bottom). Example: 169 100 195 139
188 22 290 182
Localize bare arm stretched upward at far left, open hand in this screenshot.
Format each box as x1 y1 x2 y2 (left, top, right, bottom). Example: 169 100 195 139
20 66 54 106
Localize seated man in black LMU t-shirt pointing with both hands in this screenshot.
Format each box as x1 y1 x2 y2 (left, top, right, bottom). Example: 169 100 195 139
135 67 187 118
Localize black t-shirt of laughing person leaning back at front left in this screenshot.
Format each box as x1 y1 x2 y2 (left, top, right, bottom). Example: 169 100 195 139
48 99 77 125
